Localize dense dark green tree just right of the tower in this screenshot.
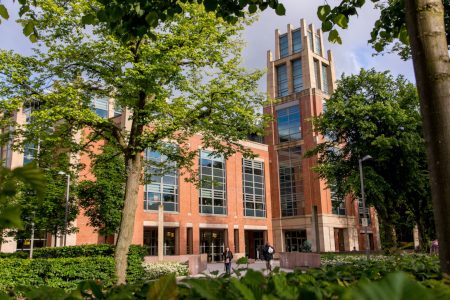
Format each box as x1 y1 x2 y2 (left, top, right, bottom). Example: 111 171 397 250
305 69 430 251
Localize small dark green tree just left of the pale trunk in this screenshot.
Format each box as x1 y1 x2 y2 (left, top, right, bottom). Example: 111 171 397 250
78 146 126 238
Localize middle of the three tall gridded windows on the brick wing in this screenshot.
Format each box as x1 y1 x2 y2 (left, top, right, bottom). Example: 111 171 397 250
198 150 227 215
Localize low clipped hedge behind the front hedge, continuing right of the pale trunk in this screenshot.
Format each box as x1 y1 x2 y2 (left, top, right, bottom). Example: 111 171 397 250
33 244 148 284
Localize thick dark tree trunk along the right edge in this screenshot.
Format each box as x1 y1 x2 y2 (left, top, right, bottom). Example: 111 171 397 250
405 0 450 274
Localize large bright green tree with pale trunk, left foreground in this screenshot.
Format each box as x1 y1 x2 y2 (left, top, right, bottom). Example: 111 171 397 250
0 0 271 284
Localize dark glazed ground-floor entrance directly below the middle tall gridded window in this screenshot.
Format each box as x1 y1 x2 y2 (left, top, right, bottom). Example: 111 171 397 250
200 230 225 262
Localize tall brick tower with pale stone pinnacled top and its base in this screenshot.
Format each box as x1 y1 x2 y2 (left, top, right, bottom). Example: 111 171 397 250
264 19 380 252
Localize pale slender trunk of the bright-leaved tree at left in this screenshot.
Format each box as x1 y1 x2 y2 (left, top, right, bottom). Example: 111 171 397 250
114 153 142 285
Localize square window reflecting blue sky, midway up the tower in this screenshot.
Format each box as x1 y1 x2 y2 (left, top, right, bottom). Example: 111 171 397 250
277 106 302 143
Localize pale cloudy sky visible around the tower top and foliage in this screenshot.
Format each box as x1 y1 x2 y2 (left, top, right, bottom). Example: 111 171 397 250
0 0 415 92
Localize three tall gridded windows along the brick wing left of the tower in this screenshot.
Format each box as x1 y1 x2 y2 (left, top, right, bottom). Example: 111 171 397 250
144 150 266 217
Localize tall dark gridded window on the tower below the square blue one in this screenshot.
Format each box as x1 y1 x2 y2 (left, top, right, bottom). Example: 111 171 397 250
278 147 305 217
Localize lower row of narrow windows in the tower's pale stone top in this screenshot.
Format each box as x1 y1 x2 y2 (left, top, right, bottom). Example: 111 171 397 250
277 59 328 97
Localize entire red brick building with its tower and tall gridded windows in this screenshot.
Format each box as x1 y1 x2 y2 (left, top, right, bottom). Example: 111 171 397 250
0 19 380 262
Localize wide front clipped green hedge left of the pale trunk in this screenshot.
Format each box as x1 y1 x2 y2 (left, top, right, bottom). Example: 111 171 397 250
0 257 115 291
